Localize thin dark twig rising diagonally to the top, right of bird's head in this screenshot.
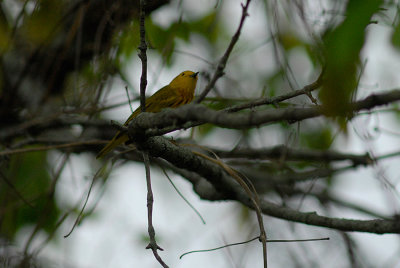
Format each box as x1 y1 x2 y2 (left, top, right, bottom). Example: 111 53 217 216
195 0 251 103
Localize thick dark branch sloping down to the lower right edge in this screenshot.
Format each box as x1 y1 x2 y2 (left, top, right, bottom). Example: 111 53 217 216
138 137 400 234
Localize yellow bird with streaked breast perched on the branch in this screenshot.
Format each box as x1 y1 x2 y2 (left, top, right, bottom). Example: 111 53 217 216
96 71 198 158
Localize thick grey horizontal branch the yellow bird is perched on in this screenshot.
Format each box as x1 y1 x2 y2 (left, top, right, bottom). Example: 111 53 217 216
130 90 400 133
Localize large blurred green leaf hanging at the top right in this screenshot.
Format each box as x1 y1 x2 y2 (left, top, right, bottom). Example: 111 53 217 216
319 0 383 125
